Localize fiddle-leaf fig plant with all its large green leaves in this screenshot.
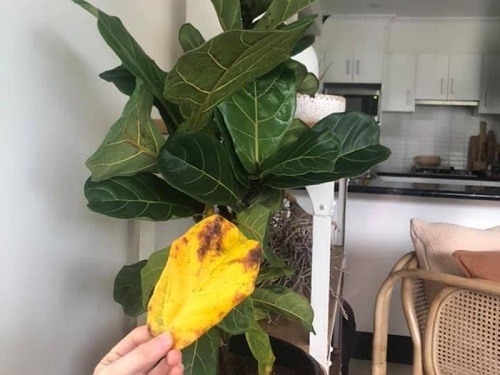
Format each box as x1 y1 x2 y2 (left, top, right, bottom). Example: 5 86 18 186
73 0 390 375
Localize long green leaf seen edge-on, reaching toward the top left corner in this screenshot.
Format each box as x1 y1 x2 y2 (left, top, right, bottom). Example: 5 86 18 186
72 0 181 134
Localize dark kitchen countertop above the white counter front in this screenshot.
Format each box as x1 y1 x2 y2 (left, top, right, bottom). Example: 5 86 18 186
348 172 500 200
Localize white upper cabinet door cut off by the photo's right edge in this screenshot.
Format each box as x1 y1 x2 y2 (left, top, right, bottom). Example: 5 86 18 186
479 55 500 114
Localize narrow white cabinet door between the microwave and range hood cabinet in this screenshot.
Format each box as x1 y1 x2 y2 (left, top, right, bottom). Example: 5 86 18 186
382 54 416 112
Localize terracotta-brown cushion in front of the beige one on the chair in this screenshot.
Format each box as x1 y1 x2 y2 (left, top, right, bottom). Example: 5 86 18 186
453 250 500 282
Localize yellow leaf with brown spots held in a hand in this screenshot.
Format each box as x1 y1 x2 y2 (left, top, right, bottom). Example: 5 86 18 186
148 215 262 349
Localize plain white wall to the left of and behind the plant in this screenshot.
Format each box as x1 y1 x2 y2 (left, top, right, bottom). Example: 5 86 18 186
0 0 184 375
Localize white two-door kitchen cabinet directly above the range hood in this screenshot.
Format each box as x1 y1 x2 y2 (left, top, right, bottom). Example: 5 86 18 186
415 54 481 101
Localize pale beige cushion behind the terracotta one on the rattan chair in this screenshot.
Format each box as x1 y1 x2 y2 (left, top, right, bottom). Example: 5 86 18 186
410 219 500 299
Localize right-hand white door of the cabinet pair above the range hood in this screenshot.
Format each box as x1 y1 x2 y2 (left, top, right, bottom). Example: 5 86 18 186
448 54 482 100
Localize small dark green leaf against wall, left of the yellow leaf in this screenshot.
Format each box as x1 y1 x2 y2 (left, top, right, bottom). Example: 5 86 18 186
113 260 146 317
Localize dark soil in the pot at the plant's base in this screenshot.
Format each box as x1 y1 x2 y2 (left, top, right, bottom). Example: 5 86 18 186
218 350 304 375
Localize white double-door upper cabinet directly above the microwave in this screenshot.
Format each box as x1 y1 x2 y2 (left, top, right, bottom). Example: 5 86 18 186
319 17 388 83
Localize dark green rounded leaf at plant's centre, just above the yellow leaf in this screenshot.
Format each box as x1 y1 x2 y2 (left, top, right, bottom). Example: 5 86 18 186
158 133 242 209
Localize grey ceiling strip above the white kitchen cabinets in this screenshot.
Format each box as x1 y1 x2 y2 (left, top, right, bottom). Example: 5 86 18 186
320 0 500 17
